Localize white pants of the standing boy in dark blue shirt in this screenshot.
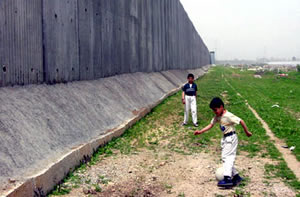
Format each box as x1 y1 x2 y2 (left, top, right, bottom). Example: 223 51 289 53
183 95 198 124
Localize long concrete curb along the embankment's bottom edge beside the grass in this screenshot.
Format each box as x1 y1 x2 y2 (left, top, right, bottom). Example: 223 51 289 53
1 66 209 197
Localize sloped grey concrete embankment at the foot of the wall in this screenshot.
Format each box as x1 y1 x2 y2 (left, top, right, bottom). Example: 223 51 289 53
0 66 208 196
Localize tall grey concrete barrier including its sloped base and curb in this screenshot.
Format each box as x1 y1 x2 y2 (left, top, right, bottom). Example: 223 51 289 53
0 0 210 196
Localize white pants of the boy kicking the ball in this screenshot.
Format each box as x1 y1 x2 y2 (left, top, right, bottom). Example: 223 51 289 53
221 134 238 177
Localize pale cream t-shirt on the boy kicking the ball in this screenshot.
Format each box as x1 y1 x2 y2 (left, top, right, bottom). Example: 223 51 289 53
211 110 241 134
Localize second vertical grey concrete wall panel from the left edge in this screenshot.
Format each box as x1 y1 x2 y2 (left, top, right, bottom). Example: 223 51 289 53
43 0 80 83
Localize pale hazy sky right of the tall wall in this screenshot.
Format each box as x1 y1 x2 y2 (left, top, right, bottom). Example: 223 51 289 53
180 0 300 60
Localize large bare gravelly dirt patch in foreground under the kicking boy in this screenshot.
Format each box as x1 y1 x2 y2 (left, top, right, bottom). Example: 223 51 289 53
63 149 295 197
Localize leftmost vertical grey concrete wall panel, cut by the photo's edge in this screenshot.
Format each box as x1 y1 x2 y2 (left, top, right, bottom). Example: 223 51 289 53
0 0 43 86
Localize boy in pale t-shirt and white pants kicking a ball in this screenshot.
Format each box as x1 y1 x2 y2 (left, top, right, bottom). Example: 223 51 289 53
195 98 252 187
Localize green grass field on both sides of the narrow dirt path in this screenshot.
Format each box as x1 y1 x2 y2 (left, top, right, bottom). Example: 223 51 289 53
51 67 300 196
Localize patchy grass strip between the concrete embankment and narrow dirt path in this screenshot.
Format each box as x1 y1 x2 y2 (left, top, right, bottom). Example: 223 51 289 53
52 67 300 195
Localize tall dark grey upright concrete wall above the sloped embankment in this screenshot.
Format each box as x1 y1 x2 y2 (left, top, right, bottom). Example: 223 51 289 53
0 0 210 86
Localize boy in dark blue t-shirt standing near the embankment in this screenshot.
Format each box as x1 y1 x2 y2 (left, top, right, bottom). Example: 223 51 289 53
182 74 198 127
